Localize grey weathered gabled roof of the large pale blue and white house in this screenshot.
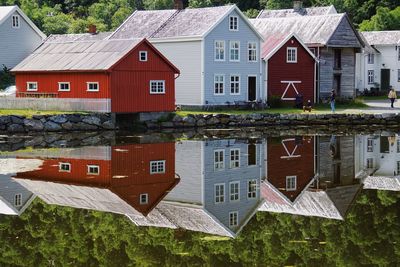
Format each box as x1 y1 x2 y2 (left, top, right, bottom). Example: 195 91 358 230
110 5 262 39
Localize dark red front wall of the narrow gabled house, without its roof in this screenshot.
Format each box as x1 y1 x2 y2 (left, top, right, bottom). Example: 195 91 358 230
267 37 315 102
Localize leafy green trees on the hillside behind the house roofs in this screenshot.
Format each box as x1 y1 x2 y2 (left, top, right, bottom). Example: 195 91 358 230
0 0 400 34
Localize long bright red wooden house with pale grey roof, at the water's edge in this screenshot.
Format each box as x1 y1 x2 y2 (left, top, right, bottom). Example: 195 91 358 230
12 39 179 113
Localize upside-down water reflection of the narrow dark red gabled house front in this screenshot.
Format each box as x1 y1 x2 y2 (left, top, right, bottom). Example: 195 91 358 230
266 136 314 202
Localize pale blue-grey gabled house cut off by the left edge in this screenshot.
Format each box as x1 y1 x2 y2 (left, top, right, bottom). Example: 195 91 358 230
0 6 46 69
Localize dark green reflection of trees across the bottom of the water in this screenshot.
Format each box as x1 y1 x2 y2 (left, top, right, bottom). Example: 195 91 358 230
0 190 400 266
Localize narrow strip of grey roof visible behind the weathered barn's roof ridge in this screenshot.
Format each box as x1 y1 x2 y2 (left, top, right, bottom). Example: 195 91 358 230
257 5 337 18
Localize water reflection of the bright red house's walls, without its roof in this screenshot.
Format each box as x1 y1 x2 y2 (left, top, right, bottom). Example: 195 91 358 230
16 143 179 215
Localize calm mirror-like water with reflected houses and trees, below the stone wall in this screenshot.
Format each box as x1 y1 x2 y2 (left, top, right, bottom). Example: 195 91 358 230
0 135 400 266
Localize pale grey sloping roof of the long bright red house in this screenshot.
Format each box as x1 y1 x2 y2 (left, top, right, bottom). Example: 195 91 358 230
12 39 141 72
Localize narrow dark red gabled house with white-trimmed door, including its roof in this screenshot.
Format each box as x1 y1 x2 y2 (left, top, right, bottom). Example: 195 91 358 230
261 33 317 102
